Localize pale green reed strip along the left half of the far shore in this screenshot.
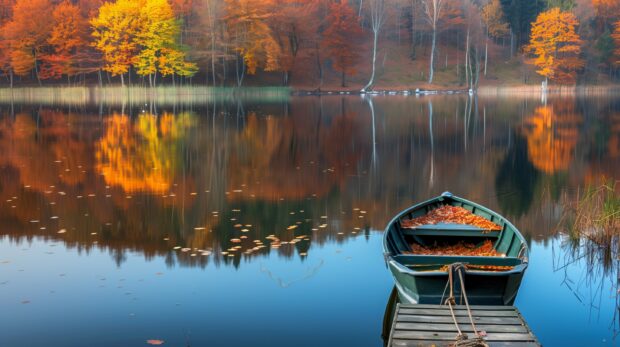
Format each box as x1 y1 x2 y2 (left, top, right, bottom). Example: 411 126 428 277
0 86 290 105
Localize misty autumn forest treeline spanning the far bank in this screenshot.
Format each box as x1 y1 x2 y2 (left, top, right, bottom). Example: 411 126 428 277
0 0 620 89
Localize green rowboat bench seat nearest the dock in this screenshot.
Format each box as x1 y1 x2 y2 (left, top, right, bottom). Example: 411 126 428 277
394 254 523 266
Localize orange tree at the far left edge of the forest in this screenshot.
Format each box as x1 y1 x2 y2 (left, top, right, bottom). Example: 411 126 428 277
3 0 52 84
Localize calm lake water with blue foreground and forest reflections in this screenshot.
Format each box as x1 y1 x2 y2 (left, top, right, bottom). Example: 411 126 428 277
0 96 620 347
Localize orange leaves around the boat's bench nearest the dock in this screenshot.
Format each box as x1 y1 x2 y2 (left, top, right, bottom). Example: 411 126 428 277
411 240 513 271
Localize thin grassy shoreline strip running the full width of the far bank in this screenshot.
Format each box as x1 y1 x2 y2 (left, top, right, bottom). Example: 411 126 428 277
0 84 620 105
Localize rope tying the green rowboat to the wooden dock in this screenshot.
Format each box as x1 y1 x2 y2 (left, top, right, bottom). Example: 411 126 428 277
441 263 489 347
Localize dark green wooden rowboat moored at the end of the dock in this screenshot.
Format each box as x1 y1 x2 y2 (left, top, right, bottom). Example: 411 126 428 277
383 192 529 305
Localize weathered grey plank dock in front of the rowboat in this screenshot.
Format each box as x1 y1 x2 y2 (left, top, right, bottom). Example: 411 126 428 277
388 304 540 347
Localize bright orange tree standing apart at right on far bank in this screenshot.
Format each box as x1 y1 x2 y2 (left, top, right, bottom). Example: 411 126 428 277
526 8 584 83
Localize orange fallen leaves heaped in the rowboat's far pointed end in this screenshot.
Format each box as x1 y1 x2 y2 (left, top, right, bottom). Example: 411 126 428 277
400 205 502 230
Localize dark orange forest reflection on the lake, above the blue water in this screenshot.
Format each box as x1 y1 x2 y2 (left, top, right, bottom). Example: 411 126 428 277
0 96 620 266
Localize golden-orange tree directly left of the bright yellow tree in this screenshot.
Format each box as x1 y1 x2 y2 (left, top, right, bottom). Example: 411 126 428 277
90 0 145 86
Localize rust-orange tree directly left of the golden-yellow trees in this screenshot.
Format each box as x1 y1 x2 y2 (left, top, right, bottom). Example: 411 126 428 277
41 0 88 79
